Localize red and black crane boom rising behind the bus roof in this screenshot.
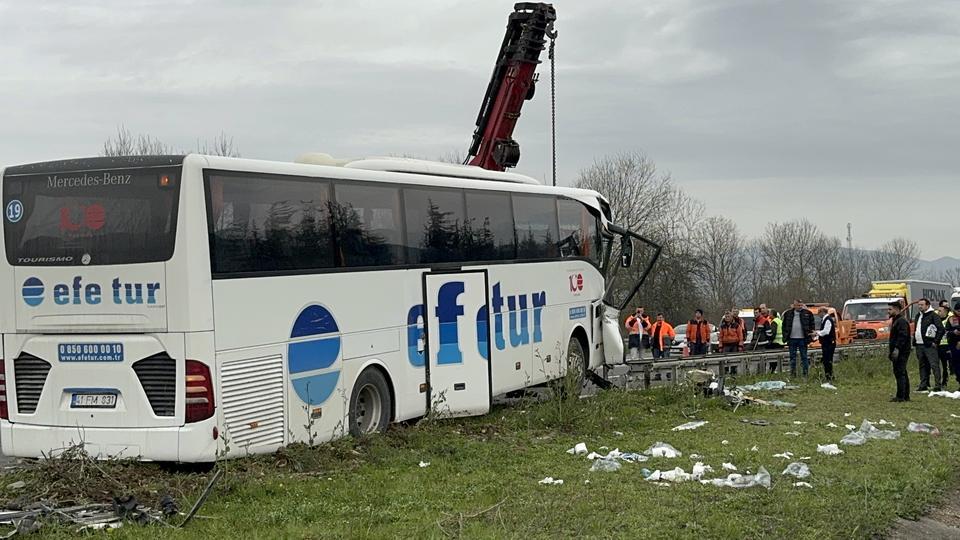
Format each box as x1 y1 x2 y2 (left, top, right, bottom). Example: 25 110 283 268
467 2 557 171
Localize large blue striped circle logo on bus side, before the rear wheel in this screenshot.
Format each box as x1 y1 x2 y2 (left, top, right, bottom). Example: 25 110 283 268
287 304 340 405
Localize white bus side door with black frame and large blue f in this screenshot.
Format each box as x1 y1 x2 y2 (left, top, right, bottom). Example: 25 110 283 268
423 270 491 416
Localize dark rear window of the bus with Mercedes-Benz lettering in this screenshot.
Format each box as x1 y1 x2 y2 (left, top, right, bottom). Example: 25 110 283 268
3 167 180 266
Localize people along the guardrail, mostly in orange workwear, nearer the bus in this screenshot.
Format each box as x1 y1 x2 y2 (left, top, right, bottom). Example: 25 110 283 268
624 300 837 380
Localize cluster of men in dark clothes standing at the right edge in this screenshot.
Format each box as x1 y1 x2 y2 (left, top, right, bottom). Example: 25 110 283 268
888 298 960 401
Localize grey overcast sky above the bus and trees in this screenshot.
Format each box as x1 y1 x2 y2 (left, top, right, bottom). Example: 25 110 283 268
0 0 960 259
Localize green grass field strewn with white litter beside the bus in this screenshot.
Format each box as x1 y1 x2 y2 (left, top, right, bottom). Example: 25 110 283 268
7 359 960 539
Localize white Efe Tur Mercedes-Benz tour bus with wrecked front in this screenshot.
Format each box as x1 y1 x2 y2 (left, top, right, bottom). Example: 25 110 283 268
0 155 659 462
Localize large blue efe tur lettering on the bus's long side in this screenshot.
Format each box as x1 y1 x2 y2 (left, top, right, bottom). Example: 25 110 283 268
407 281 547 367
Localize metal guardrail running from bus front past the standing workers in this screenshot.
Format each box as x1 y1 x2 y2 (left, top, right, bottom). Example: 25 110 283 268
605 342 888 389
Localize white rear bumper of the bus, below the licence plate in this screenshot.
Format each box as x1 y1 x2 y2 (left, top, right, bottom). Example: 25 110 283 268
0 419 217 463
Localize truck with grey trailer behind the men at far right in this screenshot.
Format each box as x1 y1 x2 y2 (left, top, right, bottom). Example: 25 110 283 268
843 279 956 341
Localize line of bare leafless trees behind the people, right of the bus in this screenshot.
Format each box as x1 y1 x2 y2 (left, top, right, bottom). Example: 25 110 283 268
576 152 960 323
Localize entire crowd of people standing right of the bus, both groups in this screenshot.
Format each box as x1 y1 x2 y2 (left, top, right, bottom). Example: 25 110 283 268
624 298 960 401
